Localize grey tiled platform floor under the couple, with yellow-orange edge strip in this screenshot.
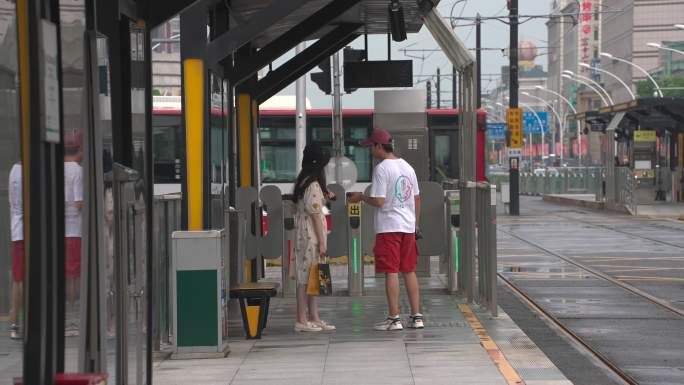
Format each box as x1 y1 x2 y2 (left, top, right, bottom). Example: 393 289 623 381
154 275 571 385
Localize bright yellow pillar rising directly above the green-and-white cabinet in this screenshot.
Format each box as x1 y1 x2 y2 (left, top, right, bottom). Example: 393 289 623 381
183 59 204 230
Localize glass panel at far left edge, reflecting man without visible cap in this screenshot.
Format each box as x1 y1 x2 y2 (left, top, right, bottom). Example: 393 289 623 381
0 0 24 378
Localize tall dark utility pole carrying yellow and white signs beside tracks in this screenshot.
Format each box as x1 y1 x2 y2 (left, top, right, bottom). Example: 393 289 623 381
508 0 520 216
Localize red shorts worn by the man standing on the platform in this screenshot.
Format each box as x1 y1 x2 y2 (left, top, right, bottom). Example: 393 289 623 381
373 233 418 273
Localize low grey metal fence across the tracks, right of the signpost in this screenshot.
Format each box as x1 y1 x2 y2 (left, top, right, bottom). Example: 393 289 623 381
520 167 604 195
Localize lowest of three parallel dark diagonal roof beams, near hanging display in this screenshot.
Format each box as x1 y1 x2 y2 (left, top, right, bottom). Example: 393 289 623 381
253 23 362 104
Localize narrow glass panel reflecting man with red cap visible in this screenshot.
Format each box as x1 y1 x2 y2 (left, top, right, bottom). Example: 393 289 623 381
59 0 86 372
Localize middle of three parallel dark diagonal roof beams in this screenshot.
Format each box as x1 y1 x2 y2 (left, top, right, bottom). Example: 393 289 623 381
226 0 360 84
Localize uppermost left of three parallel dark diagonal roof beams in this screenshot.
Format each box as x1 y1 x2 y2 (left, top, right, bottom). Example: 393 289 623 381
207 0 311 63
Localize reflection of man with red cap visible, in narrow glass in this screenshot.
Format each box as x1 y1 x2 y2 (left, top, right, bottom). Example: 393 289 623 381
64 135 83 314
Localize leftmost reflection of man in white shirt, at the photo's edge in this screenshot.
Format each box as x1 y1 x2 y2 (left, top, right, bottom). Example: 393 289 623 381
9 161 24 339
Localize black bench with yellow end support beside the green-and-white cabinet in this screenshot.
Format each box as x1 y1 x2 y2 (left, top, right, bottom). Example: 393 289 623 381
230 282 279 340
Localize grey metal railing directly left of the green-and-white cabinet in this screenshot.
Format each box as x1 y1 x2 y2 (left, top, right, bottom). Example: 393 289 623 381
152 195 181 351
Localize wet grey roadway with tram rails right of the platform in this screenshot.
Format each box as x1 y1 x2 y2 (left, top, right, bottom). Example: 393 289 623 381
499 198 684 384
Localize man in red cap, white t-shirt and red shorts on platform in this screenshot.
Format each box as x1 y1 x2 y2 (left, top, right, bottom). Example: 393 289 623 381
349 129 423 331
